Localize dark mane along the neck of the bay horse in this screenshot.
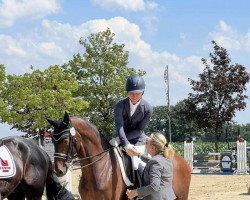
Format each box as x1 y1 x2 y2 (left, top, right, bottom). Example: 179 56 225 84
70 117 110 149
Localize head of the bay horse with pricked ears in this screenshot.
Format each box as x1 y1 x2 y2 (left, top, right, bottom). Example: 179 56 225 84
46 112 75 176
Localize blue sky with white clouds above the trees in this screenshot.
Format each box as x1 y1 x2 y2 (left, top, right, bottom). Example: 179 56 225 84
0 0 250 137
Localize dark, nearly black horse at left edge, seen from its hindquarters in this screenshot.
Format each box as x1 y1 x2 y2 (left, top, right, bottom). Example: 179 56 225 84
0 136 74 200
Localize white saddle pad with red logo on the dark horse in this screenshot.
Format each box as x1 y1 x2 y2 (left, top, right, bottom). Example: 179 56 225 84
0 145 16 179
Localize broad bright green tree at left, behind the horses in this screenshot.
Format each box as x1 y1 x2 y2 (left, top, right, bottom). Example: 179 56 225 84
0 66 88 138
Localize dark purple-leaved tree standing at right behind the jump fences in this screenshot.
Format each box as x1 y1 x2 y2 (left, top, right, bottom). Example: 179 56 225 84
184 41 250 150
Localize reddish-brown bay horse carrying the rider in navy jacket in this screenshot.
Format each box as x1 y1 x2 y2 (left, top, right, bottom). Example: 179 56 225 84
47 113 191 200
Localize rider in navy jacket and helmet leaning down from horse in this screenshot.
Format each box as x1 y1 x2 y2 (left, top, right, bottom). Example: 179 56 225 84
113 74 153 184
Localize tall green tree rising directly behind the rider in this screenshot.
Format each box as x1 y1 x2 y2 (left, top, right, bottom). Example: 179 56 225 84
63 29 145 138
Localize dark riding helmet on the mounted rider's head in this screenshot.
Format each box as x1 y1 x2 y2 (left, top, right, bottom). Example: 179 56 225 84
126 74 145 92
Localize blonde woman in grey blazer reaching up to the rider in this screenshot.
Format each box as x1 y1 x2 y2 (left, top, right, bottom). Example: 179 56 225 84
126 133 176 200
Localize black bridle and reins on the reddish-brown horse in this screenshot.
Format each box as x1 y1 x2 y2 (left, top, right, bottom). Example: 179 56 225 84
51 123 115 170
